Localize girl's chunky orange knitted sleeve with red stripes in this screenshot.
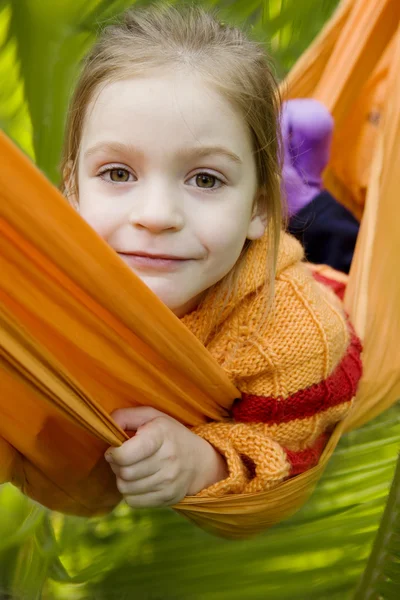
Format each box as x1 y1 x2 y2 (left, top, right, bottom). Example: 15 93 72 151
194 274 362 497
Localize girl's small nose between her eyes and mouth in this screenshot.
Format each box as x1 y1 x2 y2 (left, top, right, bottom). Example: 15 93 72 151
129 183 184 233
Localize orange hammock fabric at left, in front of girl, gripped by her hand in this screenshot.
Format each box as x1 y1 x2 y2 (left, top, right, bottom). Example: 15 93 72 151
0 134 239 514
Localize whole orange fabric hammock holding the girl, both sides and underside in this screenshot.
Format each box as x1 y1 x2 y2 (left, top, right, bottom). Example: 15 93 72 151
0 0 400 537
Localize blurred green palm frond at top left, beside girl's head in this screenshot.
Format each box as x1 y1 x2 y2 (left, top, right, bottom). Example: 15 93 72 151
0 0 136 183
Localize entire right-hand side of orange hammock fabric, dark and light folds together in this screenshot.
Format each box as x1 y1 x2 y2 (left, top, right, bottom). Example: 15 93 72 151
282 0 400 428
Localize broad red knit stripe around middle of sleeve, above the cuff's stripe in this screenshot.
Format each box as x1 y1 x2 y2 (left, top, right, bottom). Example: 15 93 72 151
232 327 362 424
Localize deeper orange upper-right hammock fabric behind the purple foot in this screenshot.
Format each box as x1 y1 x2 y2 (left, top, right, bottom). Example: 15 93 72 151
282 0 400 217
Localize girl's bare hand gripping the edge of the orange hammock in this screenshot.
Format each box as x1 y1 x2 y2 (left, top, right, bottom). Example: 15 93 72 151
105 406 228 508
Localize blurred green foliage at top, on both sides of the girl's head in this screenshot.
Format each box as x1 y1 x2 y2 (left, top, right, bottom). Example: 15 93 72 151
0 0 338 183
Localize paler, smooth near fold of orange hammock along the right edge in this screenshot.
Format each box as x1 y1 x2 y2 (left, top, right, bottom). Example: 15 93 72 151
345 19 400 428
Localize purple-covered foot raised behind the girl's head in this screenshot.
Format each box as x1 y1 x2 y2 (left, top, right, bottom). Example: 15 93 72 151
281 98 333 217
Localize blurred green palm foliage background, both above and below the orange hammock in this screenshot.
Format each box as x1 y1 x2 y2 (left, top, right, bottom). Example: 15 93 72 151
0 0 400 600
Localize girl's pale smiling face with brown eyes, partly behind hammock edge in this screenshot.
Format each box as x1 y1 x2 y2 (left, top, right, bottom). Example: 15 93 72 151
75 71 265 317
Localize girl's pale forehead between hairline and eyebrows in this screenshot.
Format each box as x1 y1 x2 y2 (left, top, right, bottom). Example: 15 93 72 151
82 72 251 157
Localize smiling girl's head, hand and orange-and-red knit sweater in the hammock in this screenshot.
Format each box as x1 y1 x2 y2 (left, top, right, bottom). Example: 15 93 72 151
63 7 361 507
